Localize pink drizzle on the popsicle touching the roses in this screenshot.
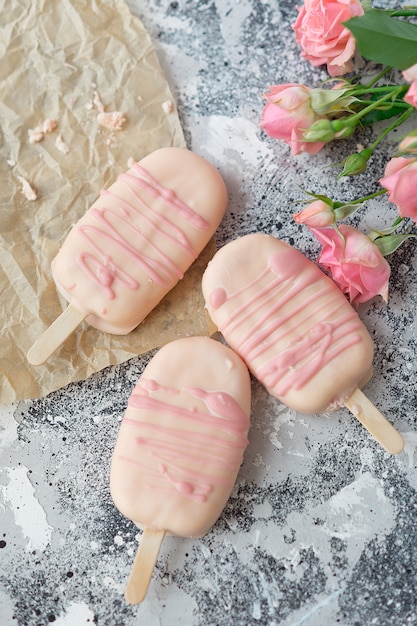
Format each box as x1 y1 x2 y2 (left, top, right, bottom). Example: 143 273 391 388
209 249 361 396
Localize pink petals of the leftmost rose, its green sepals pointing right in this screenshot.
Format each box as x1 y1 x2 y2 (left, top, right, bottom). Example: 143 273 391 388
260 83 324 155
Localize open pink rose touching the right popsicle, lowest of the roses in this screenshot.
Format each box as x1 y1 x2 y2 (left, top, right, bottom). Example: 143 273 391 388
311 224 391 304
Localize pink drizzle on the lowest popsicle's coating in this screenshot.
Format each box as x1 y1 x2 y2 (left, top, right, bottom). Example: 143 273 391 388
120 378 249 503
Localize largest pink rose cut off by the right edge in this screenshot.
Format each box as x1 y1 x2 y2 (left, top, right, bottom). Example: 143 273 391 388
379 149 417 224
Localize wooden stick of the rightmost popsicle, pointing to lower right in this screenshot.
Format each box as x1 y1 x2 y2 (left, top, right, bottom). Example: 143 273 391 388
345 389 404 454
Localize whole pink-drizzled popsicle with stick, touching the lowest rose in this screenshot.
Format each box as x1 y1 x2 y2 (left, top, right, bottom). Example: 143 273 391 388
202 233 404 453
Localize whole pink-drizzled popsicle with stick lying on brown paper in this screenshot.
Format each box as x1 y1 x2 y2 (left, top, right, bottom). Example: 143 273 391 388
28 147 227 365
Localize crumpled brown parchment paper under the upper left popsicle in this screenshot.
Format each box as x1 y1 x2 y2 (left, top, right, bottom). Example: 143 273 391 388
0 0 214 403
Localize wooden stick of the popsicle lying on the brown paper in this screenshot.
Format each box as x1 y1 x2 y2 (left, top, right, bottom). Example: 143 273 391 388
27 304 87 365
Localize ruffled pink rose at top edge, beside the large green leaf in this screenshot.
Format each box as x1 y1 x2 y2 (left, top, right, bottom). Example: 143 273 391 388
292 0 363 76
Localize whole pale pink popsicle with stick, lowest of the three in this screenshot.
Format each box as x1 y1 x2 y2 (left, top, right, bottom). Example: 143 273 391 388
110 337 251 604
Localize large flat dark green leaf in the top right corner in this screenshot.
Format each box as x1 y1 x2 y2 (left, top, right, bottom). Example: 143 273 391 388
344 9 417 70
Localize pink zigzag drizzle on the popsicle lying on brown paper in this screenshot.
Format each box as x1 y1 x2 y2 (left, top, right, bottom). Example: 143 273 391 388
77 163 210 300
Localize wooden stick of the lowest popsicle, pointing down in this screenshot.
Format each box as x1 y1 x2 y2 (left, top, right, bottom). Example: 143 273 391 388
125 528 166 604
